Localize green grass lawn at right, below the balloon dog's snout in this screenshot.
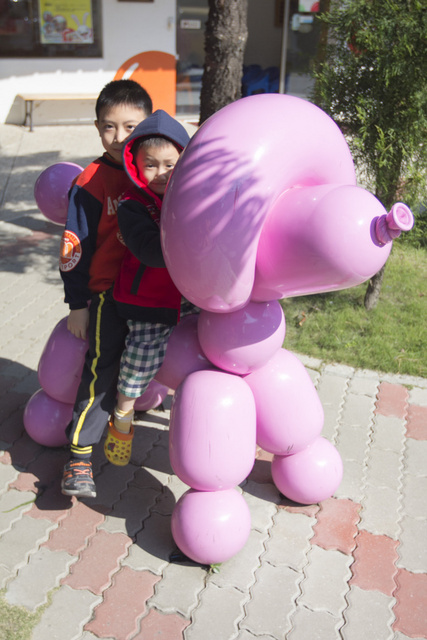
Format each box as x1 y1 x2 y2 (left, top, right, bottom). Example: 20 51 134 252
281 241 427 377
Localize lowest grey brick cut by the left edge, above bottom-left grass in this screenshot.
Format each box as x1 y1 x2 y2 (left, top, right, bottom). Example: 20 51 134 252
0 516 56 588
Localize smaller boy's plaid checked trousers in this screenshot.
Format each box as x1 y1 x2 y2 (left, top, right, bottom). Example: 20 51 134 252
117 300 199 398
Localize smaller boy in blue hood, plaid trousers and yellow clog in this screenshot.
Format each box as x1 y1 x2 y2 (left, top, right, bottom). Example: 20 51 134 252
104 110 196 465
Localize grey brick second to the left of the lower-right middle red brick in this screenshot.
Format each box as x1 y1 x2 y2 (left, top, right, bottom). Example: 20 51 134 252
240 563 302 638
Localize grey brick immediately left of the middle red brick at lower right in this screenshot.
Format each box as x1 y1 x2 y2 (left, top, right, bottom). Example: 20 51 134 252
298 546 353 618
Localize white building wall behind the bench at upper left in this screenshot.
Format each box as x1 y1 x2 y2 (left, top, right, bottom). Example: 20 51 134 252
0 0 176 124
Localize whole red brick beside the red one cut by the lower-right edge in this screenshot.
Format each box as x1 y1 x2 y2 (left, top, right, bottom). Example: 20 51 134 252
350 531 399 596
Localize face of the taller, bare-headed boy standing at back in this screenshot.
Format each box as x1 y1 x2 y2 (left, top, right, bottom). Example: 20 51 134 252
95 104 147 164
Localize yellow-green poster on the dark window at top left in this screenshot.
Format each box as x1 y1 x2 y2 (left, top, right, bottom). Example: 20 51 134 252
39 0 94 44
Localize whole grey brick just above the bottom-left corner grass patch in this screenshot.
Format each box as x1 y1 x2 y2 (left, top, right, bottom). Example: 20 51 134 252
5 547 77 611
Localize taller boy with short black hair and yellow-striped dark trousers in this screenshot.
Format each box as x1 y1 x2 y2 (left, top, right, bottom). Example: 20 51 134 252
60 80 152 497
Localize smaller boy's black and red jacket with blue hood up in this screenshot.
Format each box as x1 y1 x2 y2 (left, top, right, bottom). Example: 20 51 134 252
113 110 189 325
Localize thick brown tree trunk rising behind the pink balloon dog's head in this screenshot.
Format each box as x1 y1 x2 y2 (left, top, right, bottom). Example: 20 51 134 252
199 0 248 124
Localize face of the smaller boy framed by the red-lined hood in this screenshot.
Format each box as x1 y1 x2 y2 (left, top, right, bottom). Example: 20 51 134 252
135 141 179 196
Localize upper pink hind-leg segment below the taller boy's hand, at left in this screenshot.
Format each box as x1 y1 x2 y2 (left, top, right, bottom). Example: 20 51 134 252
37 318 88 404
